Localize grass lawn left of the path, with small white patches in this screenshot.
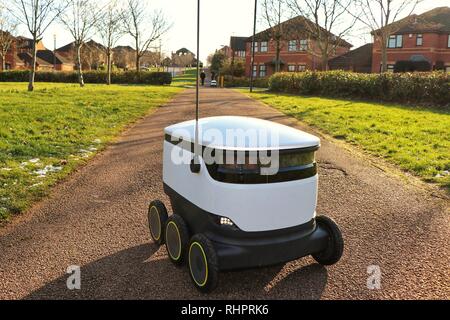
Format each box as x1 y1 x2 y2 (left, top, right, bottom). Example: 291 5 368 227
0 83 182 221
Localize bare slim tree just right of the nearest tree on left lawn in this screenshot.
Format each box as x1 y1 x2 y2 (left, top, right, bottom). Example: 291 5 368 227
59 0 97 87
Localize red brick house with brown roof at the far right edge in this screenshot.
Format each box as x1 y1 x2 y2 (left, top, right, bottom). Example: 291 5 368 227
372 7 450 73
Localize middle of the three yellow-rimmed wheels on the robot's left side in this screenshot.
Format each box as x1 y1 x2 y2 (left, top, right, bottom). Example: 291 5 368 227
165 214 189 266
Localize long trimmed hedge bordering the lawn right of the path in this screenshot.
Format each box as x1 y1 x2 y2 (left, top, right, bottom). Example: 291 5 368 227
269 71 450 106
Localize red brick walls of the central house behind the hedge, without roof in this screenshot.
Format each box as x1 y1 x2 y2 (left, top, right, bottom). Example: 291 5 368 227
245 41 349 77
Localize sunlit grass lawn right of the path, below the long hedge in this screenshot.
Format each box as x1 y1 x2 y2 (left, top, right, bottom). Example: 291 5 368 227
243 91 450 191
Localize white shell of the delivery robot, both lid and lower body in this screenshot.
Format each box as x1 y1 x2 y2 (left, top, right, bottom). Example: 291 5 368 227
163 117 320 232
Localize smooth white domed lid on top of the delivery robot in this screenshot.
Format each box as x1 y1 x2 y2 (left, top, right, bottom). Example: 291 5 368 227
165 116 320 151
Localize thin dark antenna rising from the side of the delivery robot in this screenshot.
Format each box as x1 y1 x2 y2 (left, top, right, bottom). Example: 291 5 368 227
191 0 201 173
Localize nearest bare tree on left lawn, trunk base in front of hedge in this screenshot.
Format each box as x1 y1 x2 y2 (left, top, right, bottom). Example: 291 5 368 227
10 0 66 91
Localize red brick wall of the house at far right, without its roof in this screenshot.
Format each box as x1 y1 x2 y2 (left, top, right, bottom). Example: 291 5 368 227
372 33 450 73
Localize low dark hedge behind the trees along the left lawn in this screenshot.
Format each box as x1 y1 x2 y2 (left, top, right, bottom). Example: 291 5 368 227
0 70 172 85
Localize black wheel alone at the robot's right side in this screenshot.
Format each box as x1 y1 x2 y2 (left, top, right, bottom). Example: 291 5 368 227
312 216 344 266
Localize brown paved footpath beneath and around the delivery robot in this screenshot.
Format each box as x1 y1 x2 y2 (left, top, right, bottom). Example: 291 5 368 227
0 88 450 299
